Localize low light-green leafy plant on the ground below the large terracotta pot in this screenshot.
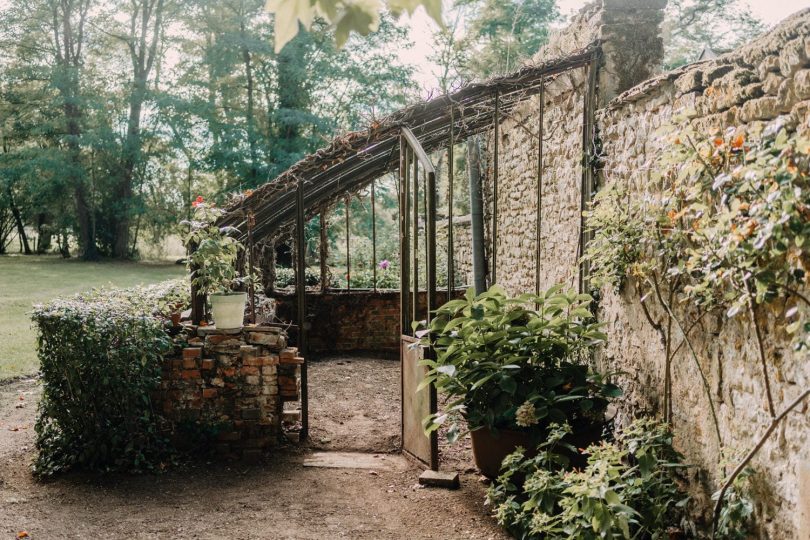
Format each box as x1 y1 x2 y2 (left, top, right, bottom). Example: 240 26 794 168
487 419 688 540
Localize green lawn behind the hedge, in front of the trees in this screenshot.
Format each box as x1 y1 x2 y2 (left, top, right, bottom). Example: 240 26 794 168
0 255 184 379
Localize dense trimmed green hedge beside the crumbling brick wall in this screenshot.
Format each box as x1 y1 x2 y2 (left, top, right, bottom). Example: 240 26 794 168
32 281 187 476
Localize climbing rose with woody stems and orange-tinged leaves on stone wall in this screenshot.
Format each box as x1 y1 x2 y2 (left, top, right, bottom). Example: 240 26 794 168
585 119 810 525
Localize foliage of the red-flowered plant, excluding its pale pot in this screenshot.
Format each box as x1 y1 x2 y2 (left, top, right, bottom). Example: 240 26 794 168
182 197 258 295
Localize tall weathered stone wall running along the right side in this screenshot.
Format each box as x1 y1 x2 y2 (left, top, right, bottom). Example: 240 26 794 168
485 0 810 538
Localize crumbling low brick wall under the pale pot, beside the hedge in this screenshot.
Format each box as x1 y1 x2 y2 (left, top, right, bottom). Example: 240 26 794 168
155 325 304 460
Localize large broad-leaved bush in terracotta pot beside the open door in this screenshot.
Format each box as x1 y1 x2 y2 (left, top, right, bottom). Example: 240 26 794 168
420 285 621 477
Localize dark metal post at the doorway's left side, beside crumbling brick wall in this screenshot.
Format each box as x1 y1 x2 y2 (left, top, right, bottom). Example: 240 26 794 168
295 180 309 440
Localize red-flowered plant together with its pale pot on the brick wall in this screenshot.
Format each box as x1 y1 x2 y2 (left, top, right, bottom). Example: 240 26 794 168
183 197 256 330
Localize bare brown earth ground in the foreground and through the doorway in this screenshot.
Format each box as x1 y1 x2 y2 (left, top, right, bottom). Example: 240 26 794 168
0 358 505 539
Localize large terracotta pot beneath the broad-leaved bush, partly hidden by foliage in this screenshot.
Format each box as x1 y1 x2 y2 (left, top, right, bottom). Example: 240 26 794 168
470 421 611 478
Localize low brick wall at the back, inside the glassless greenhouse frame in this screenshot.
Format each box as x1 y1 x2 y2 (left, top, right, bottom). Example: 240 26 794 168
271 290 463 357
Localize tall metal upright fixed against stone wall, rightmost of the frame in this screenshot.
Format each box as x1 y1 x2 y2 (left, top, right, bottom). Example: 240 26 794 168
577 49 600 293
